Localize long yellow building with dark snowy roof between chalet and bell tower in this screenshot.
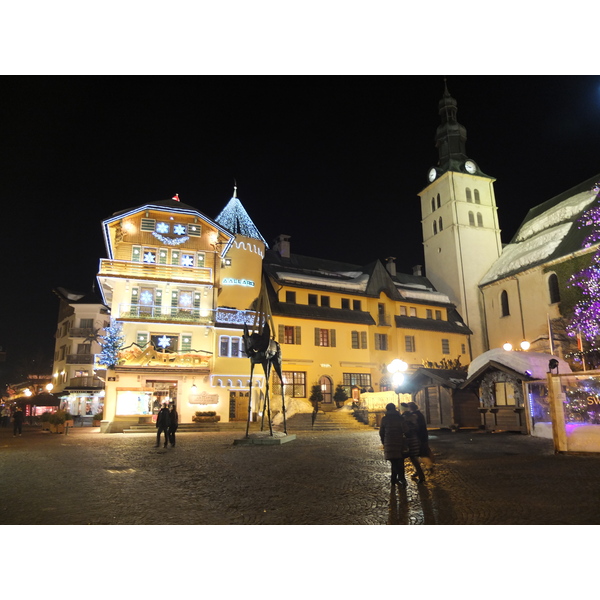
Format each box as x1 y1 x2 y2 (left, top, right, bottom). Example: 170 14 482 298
264 235 471 405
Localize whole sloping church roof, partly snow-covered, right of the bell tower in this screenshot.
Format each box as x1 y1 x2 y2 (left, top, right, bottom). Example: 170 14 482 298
480 174 600 285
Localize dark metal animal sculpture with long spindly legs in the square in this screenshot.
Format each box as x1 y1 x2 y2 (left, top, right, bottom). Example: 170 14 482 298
244 323 287 437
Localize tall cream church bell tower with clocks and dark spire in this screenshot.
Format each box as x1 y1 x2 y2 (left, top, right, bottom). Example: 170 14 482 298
419 84 502 359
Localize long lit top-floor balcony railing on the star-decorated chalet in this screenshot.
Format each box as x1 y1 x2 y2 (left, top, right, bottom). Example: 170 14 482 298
99 258 213 284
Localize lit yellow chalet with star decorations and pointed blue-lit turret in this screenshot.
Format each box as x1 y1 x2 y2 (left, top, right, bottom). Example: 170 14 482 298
97 195 266 432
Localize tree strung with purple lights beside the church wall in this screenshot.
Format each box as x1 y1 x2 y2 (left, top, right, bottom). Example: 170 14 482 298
567 184 600 351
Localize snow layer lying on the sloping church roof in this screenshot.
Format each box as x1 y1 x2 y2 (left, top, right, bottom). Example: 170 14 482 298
480 182 598 285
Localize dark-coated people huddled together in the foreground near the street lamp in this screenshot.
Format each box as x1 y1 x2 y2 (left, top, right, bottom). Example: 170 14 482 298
379 403 425 486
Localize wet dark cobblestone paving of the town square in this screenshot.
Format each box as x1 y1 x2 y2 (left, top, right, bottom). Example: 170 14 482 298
0 427 600 525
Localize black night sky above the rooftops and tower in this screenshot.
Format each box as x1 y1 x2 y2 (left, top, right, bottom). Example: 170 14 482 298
0 75 600 383
